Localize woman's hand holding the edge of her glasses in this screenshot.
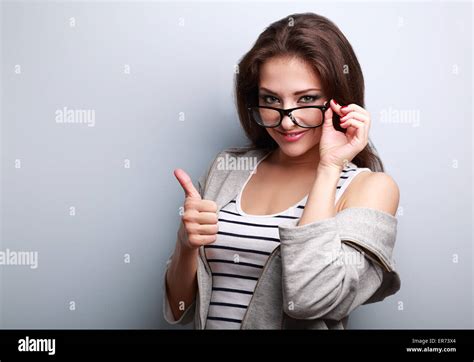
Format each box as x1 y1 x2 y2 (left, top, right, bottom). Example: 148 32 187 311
318 99 370 171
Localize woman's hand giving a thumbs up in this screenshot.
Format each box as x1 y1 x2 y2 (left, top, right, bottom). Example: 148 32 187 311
174 168 218 249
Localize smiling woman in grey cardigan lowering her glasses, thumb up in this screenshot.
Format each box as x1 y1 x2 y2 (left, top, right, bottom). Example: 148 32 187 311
163 13 400 329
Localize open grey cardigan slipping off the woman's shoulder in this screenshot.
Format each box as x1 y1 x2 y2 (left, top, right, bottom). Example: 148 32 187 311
162 147 400 329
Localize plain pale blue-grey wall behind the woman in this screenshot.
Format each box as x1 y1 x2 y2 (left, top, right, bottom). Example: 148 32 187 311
0 1 474 329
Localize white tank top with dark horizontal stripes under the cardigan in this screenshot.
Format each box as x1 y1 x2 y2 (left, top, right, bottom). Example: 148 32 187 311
204 158 370 329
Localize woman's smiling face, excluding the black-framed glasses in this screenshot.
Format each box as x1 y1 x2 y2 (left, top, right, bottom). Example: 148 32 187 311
258 57 326 157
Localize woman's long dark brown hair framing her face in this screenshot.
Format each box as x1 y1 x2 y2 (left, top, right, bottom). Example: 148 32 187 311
235 13 384 172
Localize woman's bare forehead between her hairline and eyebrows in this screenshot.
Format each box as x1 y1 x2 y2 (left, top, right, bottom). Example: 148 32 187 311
259 57 321 93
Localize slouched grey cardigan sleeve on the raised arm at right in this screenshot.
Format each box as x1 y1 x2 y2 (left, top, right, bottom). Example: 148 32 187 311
279 207 401 320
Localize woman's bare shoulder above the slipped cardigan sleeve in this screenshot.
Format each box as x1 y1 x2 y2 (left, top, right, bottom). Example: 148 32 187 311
342 172 400 216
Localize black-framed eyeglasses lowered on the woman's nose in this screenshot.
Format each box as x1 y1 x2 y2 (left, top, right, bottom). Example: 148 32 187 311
247 102 329 128
